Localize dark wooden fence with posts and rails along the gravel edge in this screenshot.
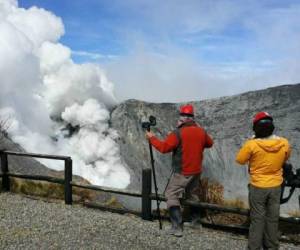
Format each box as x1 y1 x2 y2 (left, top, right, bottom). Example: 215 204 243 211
0 151 300 224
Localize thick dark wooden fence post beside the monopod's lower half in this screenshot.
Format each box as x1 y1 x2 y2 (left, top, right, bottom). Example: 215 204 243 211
142 168 152 220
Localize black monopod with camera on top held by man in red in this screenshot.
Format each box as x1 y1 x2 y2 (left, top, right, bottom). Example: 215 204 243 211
142 116 162 229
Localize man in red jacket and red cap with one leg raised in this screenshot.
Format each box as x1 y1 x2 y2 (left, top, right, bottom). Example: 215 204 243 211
146 104 213 237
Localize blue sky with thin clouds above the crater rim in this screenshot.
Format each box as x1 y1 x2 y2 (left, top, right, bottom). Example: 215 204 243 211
19 0 300 101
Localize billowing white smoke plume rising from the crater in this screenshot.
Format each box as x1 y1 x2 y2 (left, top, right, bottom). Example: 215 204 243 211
0 0 130 188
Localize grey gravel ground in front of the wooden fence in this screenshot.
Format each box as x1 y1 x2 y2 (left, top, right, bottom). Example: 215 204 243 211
0 193 299 250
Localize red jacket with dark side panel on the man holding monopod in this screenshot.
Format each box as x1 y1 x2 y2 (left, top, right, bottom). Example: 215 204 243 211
150 122 213 175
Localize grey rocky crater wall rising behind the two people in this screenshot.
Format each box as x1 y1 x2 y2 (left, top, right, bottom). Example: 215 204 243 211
111 84 300 211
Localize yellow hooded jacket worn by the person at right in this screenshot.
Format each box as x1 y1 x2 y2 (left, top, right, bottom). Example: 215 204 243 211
236 135 291 188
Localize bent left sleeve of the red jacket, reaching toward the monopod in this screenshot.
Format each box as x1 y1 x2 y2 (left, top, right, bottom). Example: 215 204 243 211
149 132 179 154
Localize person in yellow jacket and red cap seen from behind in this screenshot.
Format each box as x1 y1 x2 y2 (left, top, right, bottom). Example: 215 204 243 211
236 112 291 250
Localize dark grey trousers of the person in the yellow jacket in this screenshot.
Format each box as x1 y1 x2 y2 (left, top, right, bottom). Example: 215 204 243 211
248 185 281 250
